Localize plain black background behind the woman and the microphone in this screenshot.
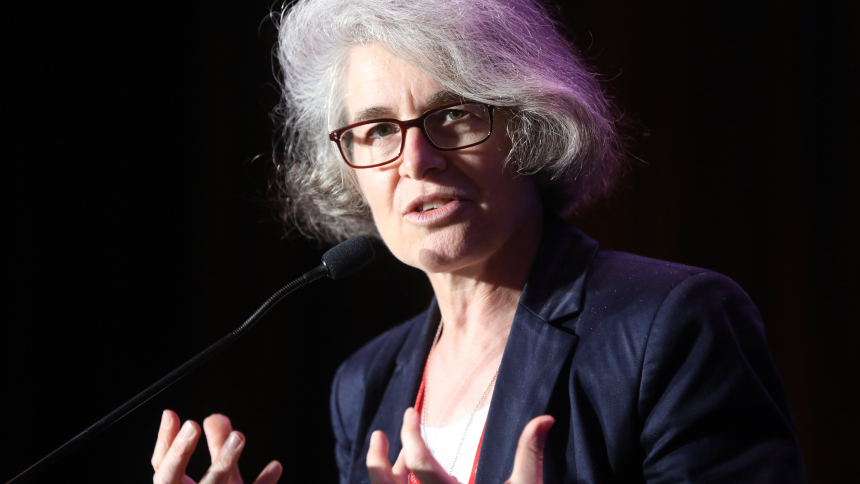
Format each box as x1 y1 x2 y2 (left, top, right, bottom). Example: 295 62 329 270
0 0 860 483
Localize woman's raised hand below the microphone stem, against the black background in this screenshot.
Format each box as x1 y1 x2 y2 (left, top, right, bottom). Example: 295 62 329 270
152 410 283 484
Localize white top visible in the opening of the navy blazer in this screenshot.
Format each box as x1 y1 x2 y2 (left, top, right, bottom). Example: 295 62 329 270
424 405 490 484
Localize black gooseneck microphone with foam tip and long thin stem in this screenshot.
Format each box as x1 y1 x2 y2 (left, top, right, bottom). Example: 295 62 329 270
6 236 376 484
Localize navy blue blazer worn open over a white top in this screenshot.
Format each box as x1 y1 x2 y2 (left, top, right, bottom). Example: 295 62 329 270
331 216 805 484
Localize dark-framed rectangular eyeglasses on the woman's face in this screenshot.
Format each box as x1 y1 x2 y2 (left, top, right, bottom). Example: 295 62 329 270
328 102 493 168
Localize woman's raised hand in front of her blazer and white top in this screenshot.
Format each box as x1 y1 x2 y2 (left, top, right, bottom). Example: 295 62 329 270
367 407 555 484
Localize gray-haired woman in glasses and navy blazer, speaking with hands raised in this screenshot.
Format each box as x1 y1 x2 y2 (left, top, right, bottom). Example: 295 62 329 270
153 0 803 484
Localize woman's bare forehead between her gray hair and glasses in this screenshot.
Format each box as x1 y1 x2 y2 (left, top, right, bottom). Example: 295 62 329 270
344 43 443 122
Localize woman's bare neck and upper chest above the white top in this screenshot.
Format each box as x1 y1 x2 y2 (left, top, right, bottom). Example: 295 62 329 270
422 215 543 427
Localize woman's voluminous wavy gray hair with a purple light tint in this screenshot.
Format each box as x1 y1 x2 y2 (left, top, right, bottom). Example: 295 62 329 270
275 0 624 242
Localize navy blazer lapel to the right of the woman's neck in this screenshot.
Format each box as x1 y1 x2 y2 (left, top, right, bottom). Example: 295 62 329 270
475 214 598 484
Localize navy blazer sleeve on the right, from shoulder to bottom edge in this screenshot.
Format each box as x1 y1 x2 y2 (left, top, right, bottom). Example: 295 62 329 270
637 272 805 484
